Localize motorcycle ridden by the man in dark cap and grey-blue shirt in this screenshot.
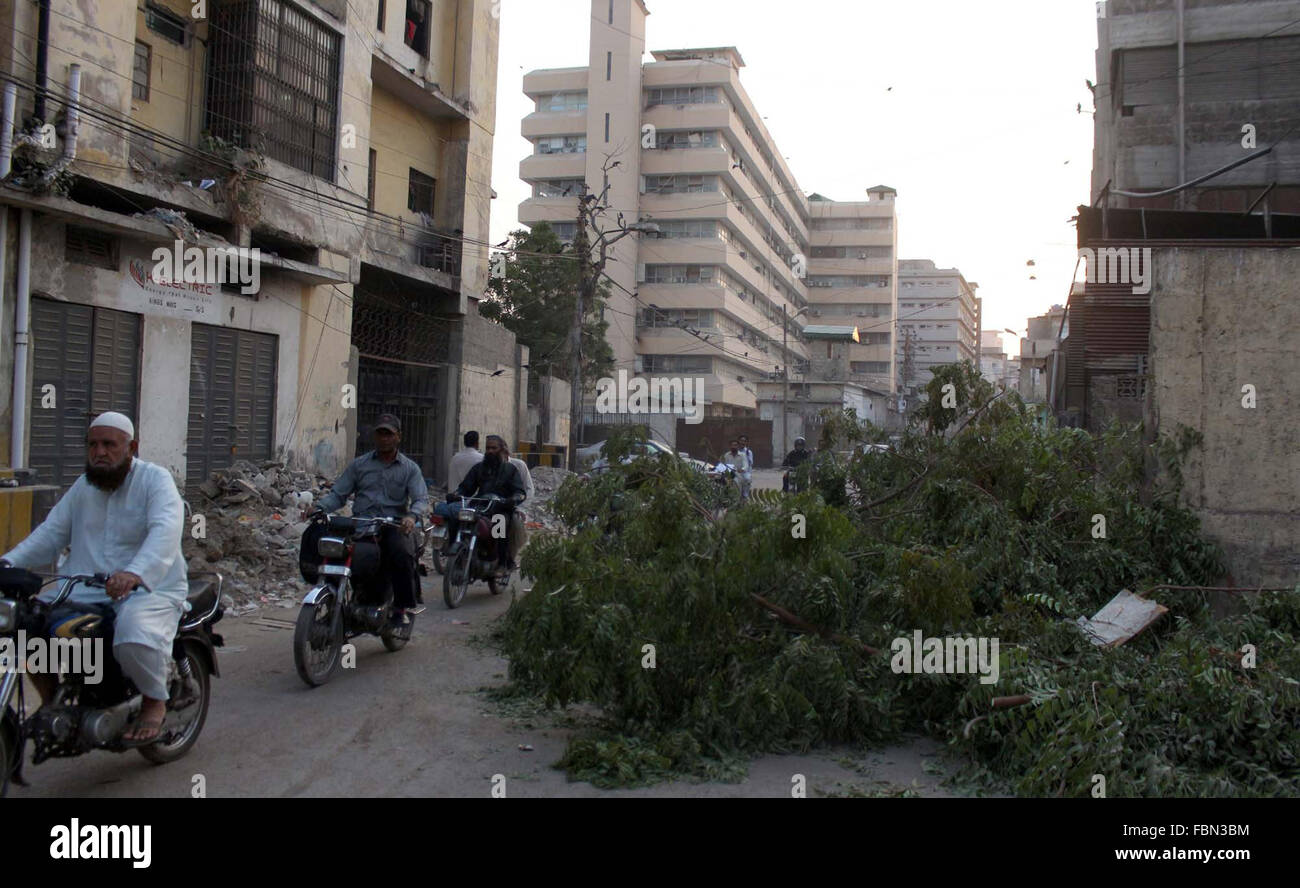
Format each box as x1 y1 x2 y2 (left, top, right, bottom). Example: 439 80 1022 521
294 512 424 688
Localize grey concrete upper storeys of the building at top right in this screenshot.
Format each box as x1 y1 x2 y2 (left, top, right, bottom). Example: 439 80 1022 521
1092 0 1300 213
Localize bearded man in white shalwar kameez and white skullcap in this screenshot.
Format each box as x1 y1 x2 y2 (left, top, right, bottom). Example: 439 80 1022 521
3 412 189 741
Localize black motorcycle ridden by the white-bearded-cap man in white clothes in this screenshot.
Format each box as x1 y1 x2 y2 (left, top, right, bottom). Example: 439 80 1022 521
0 567 222 796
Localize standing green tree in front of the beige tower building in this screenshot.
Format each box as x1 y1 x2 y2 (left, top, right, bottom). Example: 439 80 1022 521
478 222 614 380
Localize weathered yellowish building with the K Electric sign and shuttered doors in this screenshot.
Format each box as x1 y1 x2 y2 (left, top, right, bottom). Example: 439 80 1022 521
0 0 501 484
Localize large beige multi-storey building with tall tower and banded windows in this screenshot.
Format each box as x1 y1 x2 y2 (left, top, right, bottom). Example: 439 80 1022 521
519 0 896 446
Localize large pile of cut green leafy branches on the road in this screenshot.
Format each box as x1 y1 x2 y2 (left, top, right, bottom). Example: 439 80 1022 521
502 377 1300 796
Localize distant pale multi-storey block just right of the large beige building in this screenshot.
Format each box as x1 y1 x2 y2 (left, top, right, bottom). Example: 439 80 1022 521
894 259 982 395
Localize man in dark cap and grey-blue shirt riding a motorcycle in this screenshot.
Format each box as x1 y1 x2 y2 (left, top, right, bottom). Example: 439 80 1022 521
306 413 429 625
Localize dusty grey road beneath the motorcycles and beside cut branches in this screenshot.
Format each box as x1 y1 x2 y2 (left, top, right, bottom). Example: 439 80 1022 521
10 572 948 798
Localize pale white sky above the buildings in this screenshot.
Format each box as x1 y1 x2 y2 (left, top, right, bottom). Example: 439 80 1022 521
491 0 1097 355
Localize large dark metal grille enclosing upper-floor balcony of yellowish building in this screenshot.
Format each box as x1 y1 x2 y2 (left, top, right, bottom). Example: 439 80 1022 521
207 0 342 181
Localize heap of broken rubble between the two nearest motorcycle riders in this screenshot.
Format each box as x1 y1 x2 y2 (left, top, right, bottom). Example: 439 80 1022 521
182 460 329 616
